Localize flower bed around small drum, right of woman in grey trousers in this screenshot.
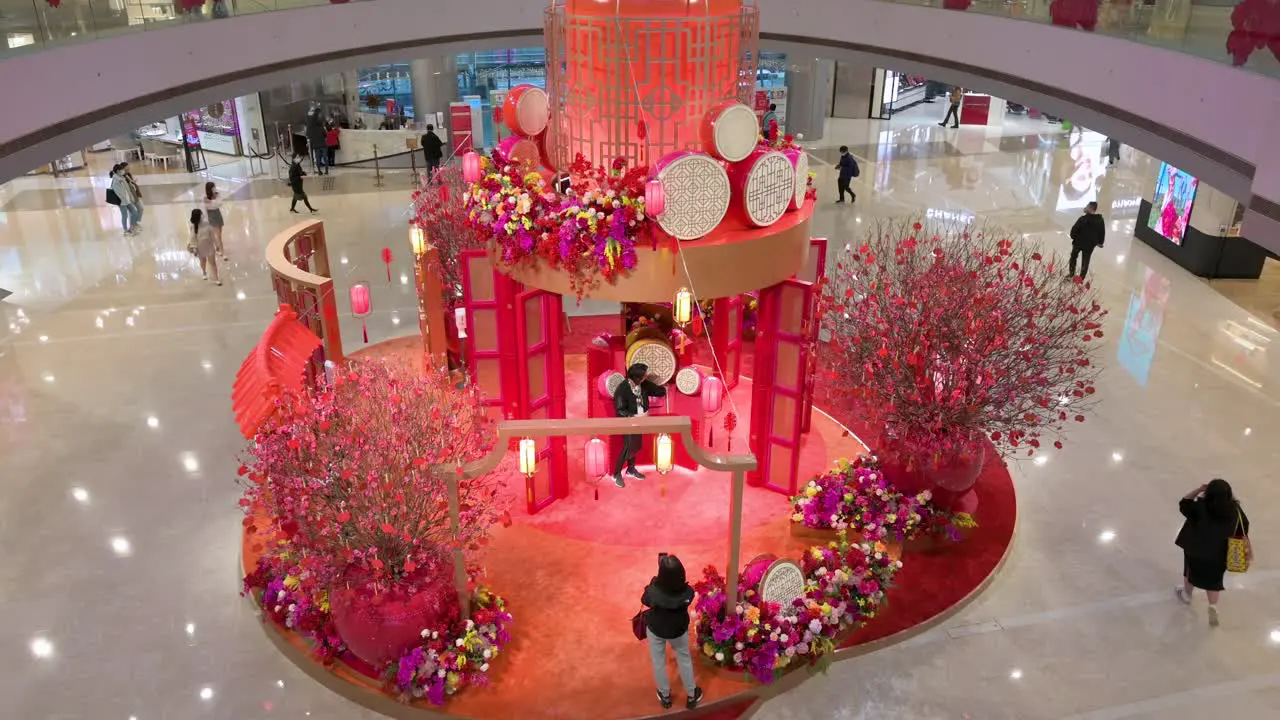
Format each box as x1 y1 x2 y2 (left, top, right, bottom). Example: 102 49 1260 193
694 534 902 684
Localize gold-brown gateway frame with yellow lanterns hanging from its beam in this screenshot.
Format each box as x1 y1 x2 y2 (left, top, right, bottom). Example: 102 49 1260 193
444 415 756 609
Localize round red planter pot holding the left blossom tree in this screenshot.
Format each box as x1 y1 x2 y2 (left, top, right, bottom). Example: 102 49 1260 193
329 573 460 669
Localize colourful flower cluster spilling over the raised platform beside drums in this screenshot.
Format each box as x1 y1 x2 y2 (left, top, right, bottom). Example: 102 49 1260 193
466 154 653 297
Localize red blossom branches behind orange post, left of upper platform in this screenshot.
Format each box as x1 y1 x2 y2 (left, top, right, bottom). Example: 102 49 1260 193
411 164 488 310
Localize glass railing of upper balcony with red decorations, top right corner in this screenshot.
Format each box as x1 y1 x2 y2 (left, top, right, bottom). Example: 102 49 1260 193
884 0 1280 82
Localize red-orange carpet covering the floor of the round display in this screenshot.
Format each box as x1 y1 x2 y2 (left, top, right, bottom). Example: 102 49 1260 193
257 333 1015 720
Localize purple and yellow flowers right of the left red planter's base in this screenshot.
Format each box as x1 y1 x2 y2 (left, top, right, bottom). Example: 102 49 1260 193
384 588 512 705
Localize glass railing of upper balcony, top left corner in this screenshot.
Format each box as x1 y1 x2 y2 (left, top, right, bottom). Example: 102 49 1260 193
0 0 371 59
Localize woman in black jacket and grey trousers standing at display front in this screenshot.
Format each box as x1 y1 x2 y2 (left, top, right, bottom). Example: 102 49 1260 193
640 552 703 710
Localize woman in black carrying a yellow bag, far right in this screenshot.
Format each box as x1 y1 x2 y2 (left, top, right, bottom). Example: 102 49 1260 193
1174 478 1253 628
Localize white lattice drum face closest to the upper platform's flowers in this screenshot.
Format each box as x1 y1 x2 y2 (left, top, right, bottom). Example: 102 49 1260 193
658 150 732 240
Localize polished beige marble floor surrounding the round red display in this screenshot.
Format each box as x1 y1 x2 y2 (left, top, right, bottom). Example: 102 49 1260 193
0 105 1280 720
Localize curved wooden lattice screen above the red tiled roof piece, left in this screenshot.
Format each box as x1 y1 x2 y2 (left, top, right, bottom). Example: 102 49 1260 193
266 220 346 382
